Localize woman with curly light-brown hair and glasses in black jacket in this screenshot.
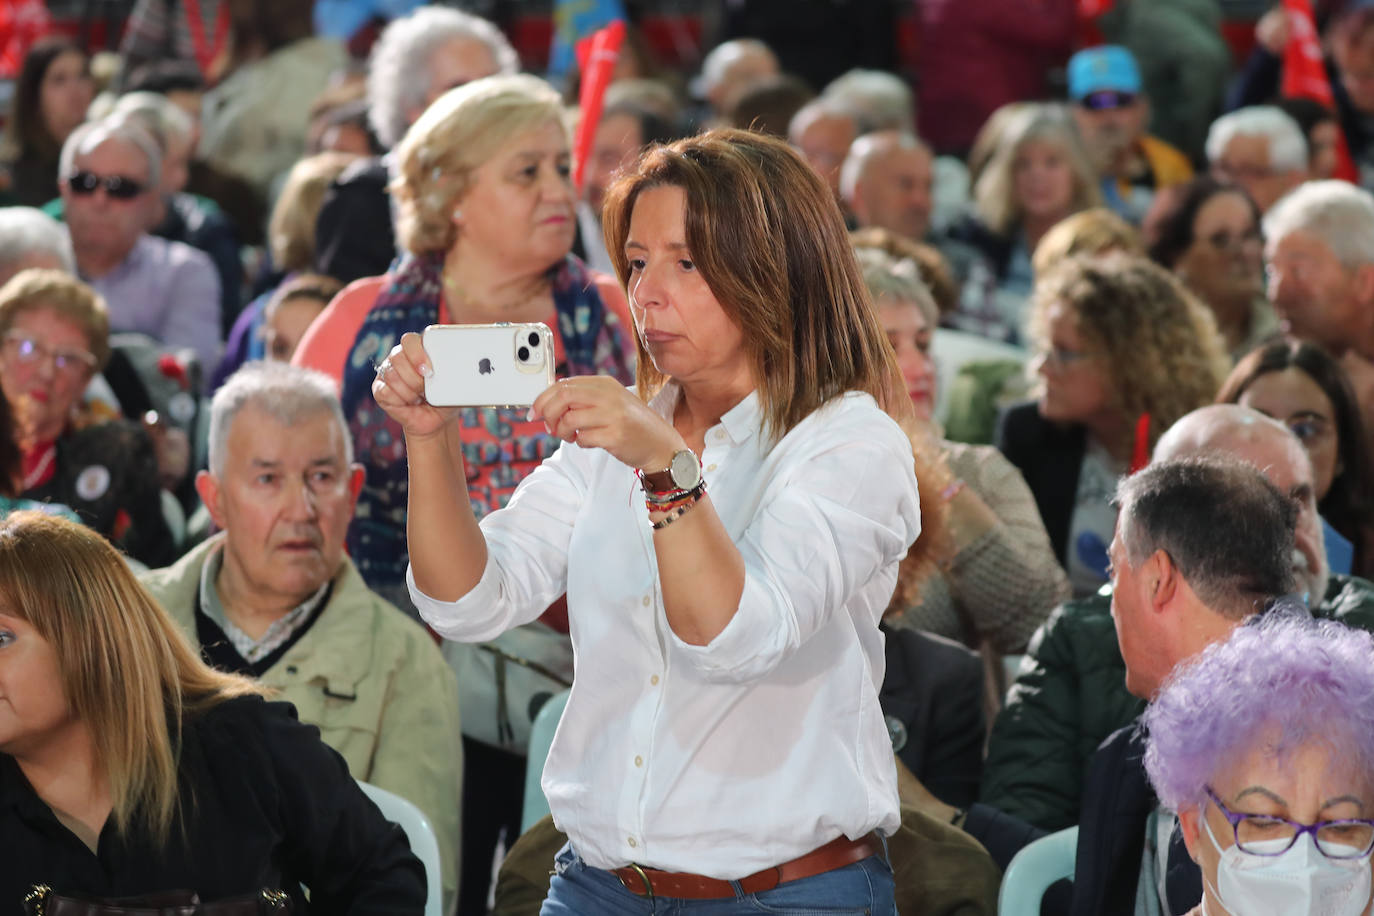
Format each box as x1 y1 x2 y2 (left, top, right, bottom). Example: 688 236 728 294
998 254 1230 596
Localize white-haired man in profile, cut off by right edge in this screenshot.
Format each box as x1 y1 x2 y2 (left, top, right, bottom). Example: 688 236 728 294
1264 180 1374 430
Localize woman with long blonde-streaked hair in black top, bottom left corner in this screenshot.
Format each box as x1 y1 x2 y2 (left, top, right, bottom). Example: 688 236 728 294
0 512 425 916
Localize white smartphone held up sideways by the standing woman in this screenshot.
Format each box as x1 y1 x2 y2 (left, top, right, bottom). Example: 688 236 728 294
420 321 554 407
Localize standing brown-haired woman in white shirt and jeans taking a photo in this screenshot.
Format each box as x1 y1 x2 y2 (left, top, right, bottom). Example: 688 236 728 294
372 130 921 916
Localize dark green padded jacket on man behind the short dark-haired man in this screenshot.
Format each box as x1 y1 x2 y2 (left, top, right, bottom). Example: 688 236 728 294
980 575 1374 831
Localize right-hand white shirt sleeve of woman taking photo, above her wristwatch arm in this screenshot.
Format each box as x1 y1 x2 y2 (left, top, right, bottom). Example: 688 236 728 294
671 413 921 683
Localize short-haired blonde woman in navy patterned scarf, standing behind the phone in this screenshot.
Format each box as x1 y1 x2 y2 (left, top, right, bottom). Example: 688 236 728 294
291 76 633 912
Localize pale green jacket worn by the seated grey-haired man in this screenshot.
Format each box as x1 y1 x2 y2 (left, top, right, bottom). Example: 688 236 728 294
139 534 463 898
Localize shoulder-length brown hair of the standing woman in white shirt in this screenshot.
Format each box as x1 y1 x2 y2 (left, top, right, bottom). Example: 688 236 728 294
602 129 911 438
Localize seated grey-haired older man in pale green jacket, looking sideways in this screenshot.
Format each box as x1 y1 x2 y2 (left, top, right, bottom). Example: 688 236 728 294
142 363 463 898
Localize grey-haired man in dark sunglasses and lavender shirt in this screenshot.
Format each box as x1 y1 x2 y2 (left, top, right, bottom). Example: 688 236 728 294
58 119 220 390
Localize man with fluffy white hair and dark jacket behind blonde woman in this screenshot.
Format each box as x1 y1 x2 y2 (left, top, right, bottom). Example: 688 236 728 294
315 5 519 283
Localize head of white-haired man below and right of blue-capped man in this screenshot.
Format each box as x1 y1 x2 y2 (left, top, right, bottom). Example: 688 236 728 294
1206 104 1307 213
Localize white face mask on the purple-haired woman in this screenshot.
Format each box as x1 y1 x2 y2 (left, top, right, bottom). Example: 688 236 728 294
1202 816 1371 916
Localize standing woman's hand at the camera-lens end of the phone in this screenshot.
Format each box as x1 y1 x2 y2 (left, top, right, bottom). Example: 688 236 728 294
529 375 687 474
